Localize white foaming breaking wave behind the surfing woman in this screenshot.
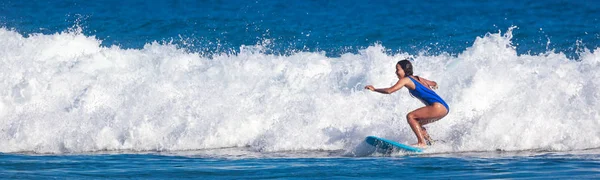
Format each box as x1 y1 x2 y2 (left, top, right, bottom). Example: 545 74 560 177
0 28 600 153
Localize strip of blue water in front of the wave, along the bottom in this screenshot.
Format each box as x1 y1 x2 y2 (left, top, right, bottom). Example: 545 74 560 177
0 150 600 179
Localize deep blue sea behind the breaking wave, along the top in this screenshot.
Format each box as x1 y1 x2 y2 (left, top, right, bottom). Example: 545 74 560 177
0 0 600 56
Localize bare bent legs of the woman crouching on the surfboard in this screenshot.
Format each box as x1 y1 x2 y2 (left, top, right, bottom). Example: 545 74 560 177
406 103 448 147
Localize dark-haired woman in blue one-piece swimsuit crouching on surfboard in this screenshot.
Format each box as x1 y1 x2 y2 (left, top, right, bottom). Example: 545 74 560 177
365 60 450 148
